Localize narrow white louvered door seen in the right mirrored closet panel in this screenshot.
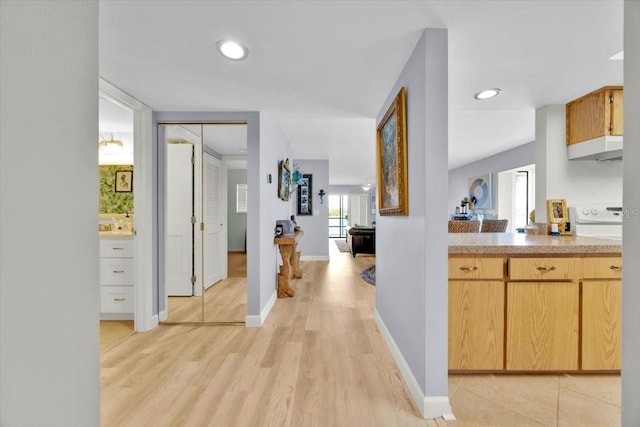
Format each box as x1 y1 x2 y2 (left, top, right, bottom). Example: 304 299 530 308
203 153 227 288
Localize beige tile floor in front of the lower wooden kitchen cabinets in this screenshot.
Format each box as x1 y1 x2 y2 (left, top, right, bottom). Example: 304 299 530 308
447 374 621 427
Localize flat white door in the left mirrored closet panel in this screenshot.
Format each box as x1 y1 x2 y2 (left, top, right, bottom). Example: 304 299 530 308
165 144 193 296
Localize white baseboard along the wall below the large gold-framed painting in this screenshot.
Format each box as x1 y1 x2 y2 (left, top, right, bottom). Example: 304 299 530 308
373 310 456 421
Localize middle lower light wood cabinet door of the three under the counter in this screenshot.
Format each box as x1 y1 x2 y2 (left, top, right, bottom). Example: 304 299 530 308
506 282 579 371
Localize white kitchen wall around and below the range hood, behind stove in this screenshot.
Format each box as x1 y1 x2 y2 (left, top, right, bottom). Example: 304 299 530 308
535 105 629 222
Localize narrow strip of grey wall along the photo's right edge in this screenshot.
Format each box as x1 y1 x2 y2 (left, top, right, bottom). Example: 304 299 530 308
622 0 640 427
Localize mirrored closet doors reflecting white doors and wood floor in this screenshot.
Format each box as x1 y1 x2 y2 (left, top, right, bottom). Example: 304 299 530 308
158 123 247 325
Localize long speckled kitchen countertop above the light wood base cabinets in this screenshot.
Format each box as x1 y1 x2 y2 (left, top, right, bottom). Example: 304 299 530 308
449 233 622 256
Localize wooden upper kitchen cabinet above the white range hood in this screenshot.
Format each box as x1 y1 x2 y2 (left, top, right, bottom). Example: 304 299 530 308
567 86 624 145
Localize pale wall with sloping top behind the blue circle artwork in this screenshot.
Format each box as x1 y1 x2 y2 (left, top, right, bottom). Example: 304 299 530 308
448 142 535 214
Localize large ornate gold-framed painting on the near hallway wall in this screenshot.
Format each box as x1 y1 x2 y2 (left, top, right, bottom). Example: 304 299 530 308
377 87 409 215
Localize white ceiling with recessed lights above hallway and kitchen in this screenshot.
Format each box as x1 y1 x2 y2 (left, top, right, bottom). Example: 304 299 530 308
100 0 623 185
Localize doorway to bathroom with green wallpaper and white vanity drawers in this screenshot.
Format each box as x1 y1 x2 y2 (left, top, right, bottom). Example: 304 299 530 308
96 92 136 353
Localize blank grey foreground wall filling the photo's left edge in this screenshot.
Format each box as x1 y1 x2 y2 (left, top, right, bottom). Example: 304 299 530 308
0 1 100 427
